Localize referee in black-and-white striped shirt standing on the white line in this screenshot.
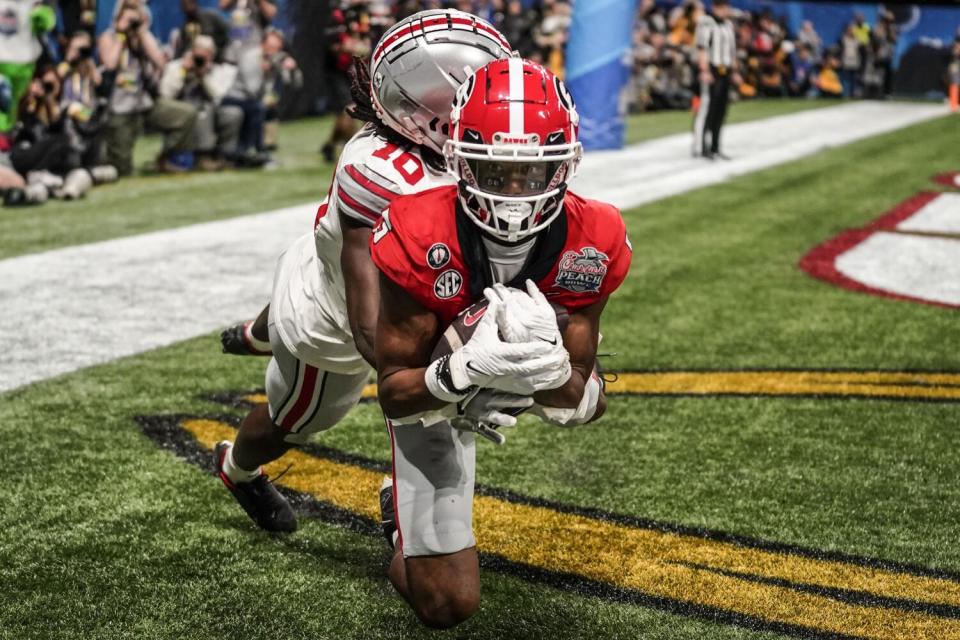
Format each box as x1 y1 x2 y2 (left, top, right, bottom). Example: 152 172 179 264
693 0 740 160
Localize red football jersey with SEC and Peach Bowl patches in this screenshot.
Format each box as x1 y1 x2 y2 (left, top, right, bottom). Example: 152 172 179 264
370 186 633 326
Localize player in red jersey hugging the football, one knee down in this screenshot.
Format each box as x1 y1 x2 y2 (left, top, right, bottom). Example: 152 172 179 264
370 58 632 627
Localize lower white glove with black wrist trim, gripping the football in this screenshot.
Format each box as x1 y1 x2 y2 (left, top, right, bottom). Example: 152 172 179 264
424 302 570 402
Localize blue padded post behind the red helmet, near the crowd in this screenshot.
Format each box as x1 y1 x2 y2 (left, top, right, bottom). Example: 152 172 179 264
566 0 637 149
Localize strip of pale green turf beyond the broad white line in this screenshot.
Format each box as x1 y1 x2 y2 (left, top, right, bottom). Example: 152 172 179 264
0 100 835 259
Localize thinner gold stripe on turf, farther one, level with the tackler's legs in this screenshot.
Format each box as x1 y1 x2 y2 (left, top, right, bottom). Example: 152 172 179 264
243 371 960 403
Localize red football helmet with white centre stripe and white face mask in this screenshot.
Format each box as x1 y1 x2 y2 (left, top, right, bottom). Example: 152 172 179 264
444 58 583 243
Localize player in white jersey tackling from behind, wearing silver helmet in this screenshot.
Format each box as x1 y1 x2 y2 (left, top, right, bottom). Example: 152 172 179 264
215 10 510 532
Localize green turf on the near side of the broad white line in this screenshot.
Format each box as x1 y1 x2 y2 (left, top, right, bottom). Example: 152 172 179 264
0 111 960 639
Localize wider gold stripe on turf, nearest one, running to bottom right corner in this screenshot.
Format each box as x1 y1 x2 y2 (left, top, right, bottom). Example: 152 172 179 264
183 419 960 640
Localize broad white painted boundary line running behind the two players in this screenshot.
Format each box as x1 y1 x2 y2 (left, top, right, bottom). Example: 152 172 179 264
0 103 945 392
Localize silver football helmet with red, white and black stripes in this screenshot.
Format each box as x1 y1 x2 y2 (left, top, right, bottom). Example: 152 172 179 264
370 9 510 153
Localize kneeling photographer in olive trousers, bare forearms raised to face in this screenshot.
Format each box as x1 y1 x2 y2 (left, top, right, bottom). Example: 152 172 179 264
99 0 197 175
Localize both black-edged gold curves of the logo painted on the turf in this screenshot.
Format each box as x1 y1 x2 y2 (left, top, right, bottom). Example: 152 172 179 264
137 371 960 640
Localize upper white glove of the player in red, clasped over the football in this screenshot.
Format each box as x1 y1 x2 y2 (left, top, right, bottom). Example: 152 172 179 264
483 280 563 344
